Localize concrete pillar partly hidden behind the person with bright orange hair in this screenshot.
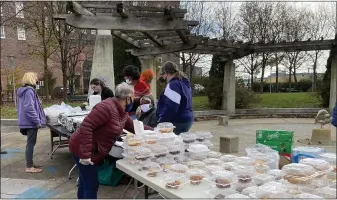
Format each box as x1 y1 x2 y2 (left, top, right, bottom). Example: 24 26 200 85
139 56 157 102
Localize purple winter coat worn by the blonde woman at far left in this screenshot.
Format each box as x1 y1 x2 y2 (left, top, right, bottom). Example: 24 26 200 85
17 86 47 128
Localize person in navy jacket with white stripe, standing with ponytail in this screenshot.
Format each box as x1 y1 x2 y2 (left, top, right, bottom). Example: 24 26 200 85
157 61 194 135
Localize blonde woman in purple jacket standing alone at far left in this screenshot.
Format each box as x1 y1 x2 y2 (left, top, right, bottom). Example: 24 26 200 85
17 72 46 173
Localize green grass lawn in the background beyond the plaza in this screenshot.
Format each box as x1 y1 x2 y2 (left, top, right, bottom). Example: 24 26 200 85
1 93 320 119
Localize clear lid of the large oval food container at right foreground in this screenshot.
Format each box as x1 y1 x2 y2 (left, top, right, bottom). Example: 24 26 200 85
282 163 315 176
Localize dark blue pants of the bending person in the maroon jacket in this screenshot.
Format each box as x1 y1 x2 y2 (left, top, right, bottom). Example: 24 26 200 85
73 154 99 199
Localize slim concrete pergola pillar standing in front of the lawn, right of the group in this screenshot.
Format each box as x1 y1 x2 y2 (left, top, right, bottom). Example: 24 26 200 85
222 59 235 114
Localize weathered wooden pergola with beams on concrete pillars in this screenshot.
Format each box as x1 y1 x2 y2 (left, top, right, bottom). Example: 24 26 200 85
54 2 337 111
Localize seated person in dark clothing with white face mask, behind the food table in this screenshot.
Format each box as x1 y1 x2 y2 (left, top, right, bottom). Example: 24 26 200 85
138 95 158 128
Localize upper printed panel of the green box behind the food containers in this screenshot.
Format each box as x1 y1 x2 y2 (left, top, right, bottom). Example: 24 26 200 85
256 130 294 142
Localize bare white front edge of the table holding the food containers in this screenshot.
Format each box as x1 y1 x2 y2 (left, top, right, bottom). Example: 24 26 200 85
117 159 210 199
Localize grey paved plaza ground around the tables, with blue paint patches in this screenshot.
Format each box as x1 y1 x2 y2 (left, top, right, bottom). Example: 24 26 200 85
1 118 336 199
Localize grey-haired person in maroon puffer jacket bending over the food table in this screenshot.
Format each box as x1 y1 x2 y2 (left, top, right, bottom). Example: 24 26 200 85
69 83 152 199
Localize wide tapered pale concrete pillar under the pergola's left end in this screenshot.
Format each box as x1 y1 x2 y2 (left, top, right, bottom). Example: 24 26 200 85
89 30 115 94
